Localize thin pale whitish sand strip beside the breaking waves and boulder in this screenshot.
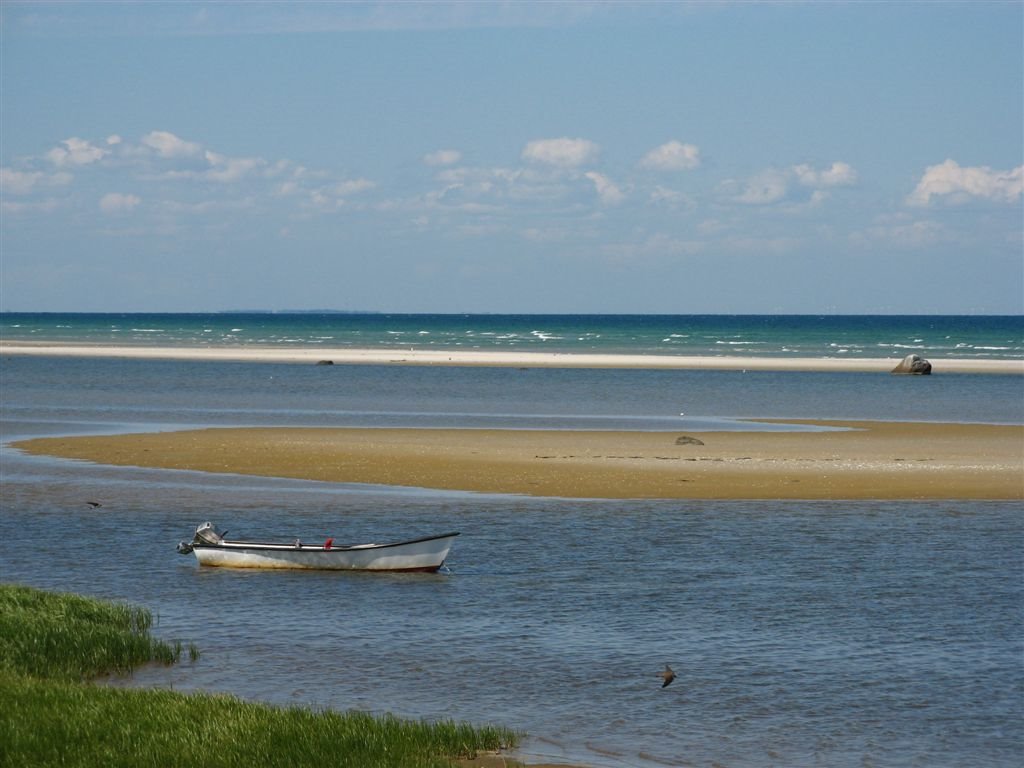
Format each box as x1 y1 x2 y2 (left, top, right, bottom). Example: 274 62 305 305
0 341 1024 375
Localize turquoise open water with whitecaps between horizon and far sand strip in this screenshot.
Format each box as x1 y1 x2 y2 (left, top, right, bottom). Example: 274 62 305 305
0 312 1024 359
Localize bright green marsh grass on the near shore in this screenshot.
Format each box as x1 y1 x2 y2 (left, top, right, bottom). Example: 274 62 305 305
0 585 517 768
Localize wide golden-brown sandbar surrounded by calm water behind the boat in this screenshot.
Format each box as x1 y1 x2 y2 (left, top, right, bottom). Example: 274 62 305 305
14 421 1024 500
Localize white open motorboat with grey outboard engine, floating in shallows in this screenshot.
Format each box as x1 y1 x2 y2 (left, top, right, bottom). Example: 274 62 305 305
177 522 459 573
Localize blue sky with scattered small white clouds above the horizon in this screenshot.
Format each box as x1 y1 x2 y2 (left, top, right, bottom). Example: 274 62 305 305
0 0 1024 314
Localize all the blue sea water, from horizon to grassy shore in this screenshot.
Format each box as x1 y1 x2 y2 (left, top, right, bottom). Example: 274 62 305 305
0 313 1024 768
